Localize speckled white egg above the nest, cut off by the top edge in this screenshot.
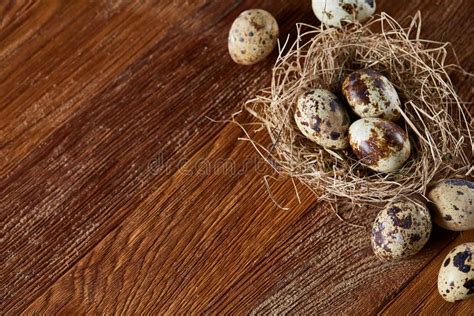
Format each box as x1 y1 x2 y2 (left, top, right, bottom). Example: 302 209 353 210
313 0 375 27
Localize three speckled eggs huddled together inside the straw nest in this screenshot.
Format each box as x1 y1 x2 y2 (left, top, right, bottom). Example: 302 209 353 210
294 69 411 172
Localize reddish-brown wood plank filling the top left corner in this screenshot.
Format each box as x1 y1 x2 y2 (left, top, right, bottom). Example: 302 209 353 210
0 1 196 174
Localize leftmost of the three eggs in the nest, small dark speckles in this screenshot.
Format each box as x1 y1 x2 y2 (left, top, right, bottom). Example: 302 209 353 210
295 89 351 149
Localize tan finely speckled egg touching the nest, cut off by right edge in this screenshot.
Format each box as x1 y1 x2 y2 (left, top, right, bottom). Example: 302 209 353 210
428 179 474 231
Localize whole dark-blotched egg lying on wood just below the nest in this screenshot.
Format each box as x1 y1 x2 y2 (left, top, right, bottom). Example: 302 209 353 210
372 200 431 260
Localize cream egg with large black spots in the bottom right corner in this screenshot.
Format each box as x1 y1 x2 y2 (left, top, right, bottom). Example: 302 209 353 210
438 242 474 302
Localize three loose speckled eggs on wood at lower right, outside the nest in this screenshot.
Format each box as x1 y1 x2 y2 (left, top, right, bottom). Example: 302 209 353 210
371 179 474 302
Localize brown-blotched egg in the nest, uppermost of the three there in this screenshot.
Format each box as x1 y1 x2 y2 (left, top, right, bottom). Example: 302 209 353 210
342 69 400 121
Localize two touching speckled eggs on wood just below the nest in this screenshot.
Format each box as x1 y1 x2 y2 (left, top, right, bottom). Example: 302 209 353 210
372 179 474 262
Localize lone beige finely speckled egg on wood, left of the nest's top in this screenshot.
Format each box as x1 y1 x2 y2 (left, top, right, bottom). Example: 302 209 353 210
228 9 278 65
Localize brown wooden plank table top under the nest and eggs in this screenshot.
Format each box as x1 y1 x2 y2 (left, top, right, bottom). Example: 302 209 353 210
0 0 474 314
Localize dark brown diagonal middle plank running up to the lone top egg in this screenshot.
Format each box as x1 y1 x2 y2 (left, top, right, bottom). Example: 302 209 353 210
0 1 308 308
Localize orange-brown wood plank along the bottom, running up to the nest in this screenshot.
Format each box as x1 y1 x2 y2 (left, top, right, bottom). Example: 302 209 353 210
19 120 460 314
